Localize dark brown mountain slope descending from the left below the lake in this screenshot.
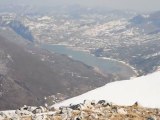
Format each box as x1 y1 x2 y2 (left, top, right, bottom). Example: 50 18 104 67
0 34 112 110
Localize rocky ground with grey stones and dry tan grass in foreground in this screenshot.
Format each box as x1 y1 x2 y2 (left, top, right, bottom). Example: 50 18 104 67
0 100 160 120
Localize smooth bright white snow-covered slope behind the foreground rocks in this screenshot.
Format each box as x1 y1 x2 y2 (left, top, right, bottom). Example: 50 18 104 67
52 71 160 108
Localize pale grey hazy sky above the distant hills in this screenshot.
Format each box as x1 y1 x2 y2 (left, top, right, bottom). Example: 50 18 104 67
0 0 160 11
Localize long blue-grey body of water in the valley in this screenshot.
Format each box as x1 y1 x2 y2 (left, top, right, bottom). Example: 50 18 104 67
41 44 136 79
